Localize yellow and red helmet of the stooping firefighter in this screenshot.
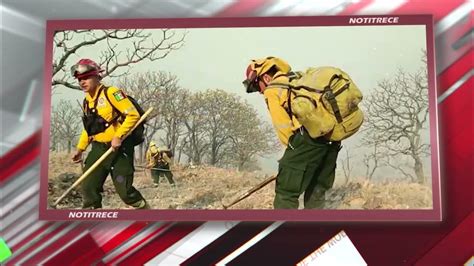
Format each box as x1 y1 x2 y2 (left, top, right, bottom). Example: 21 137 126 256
242 56 291 93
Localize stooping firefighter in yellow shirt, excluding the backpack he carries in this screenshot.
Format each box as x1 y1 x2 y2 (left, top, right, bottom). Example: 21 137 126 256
243 57 341 209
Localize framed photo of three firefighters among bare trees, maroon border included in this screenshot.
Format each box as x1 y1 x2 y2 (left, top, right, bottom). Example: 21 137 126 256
42 16 440 220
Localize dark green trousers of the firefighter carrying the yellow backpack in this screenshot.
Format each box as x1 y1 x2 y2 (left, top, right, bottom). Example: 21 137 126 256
273 128 341 209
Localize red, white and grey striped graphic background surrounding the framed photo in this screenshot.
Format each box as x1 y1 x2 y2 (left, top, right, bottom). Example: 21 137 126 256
0 0 474 265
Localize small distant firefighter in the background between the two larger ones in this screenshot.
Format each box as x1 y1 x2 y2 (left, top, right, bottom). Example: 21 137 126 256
146 141 175 187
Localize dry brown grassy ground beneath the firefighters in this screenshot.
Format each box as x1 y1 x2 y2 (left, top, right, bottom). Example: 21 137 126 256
48 153 432 209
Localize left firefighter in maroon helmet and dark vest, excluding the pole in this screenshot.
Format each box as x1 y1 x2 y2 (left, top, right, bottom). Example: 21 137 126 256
71 59 149 209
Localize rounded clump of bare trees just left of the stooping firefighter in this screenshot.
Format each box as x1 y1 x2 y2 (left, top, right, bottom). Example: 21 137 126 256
179 89 278 170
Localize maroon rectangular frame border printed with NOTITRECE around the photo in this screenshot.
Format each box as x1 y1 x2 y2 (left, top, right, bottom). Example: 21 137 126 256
39 14 443 222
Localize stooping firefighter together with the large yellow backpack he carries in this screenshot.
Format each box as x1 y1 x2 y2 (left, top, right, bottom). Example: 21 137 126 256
243 57 363 209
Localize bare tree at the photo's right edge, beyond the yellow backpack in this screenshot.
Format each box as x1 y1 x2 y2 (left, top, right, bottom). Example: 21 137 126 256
364 54 429 183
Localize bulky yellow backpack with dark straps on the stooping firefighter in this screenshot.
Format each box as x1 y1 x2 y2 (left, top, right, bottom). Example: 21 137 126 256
268 66 364 141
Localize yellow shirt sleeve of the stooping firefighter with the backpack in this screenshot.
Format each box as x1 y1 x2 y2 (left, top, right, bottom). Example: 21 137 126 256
263 74 301 146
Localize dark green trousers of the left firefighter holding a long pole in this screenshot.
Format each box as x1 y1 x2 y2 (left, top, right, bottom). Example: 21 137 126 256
81 140 146 209
